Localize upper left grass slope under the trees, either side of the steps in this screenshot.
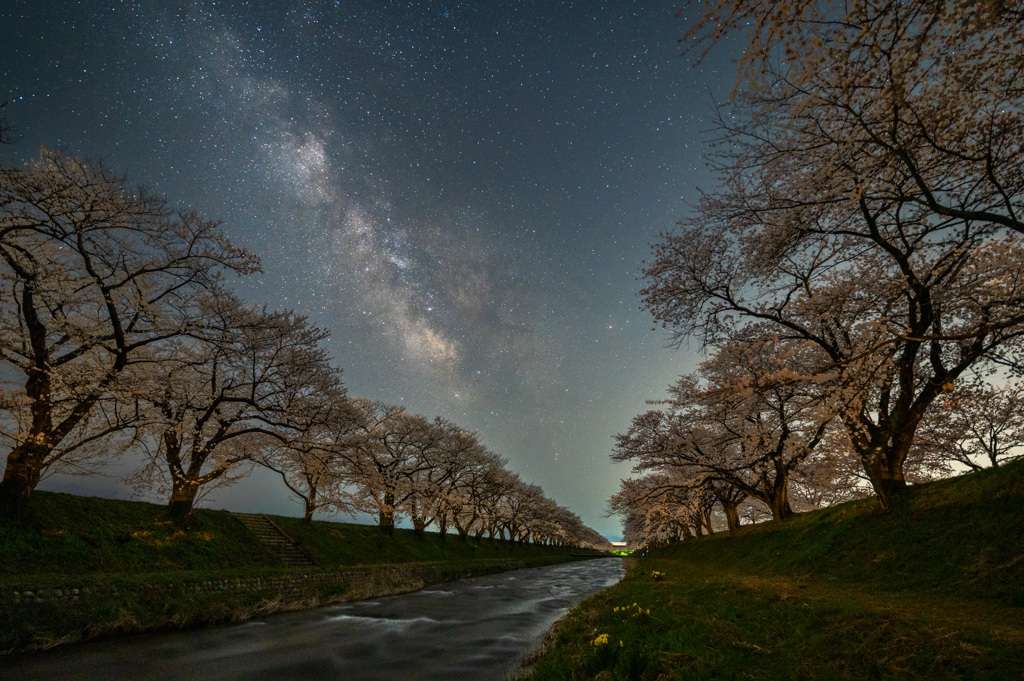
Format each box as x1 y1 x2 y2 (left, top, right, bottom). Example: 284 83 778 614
0 492 598 584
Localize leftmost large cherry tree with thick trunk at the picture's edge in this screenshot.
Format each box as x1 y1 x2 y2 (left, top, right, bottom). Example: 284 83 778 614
0 150 258 517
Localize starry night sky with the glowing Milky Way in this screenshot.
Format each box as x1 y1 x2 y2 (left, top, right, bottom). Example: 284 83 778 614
0 0 735 539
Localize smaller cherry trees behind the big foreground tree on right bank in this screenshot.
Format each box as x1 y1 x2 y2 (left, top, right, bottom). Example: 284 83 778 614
611 340 1024 545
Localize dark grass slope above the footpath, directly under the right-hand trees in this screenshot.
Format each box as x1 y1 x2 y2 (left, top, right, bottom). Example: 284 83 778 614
650 460 1024 614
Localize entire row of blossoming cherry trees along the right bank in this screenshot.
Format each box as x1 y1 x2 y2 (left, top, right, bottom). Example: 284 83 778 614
612 0 1024 536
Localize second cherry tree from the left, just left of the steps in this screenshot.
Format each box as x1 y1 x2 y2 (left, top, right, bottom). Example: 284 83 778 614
128 293 344 522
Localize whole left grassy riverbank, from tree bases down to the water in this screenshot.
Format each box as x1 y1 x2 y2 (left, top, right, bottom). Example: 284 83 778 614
0 493 600 652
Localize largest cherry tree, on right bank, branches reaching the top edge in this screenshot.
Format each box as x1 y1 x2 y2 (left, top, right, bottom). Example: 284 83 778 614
643 0 1024 509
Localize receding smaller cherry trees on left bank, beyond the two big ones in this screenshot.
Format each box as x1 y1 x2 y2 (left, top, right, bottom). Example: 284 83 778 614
243 398 607 548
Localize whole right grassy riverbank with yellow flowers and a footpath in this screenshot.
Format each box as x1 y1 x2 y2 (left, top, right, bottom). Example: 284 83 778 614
520 461 1024 681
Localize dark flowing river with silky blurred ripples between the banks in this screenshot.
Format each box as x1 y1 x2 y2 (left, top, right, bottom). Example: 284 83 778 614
0 558 623 681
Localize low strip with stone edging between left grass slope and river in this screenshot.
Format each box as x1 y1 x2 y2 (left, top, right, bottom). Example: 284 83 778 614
0 555 584 653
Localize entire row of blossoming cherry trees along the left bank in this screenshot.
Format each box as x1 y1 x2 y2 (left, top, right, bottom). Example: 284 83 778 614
0 151 605 546
